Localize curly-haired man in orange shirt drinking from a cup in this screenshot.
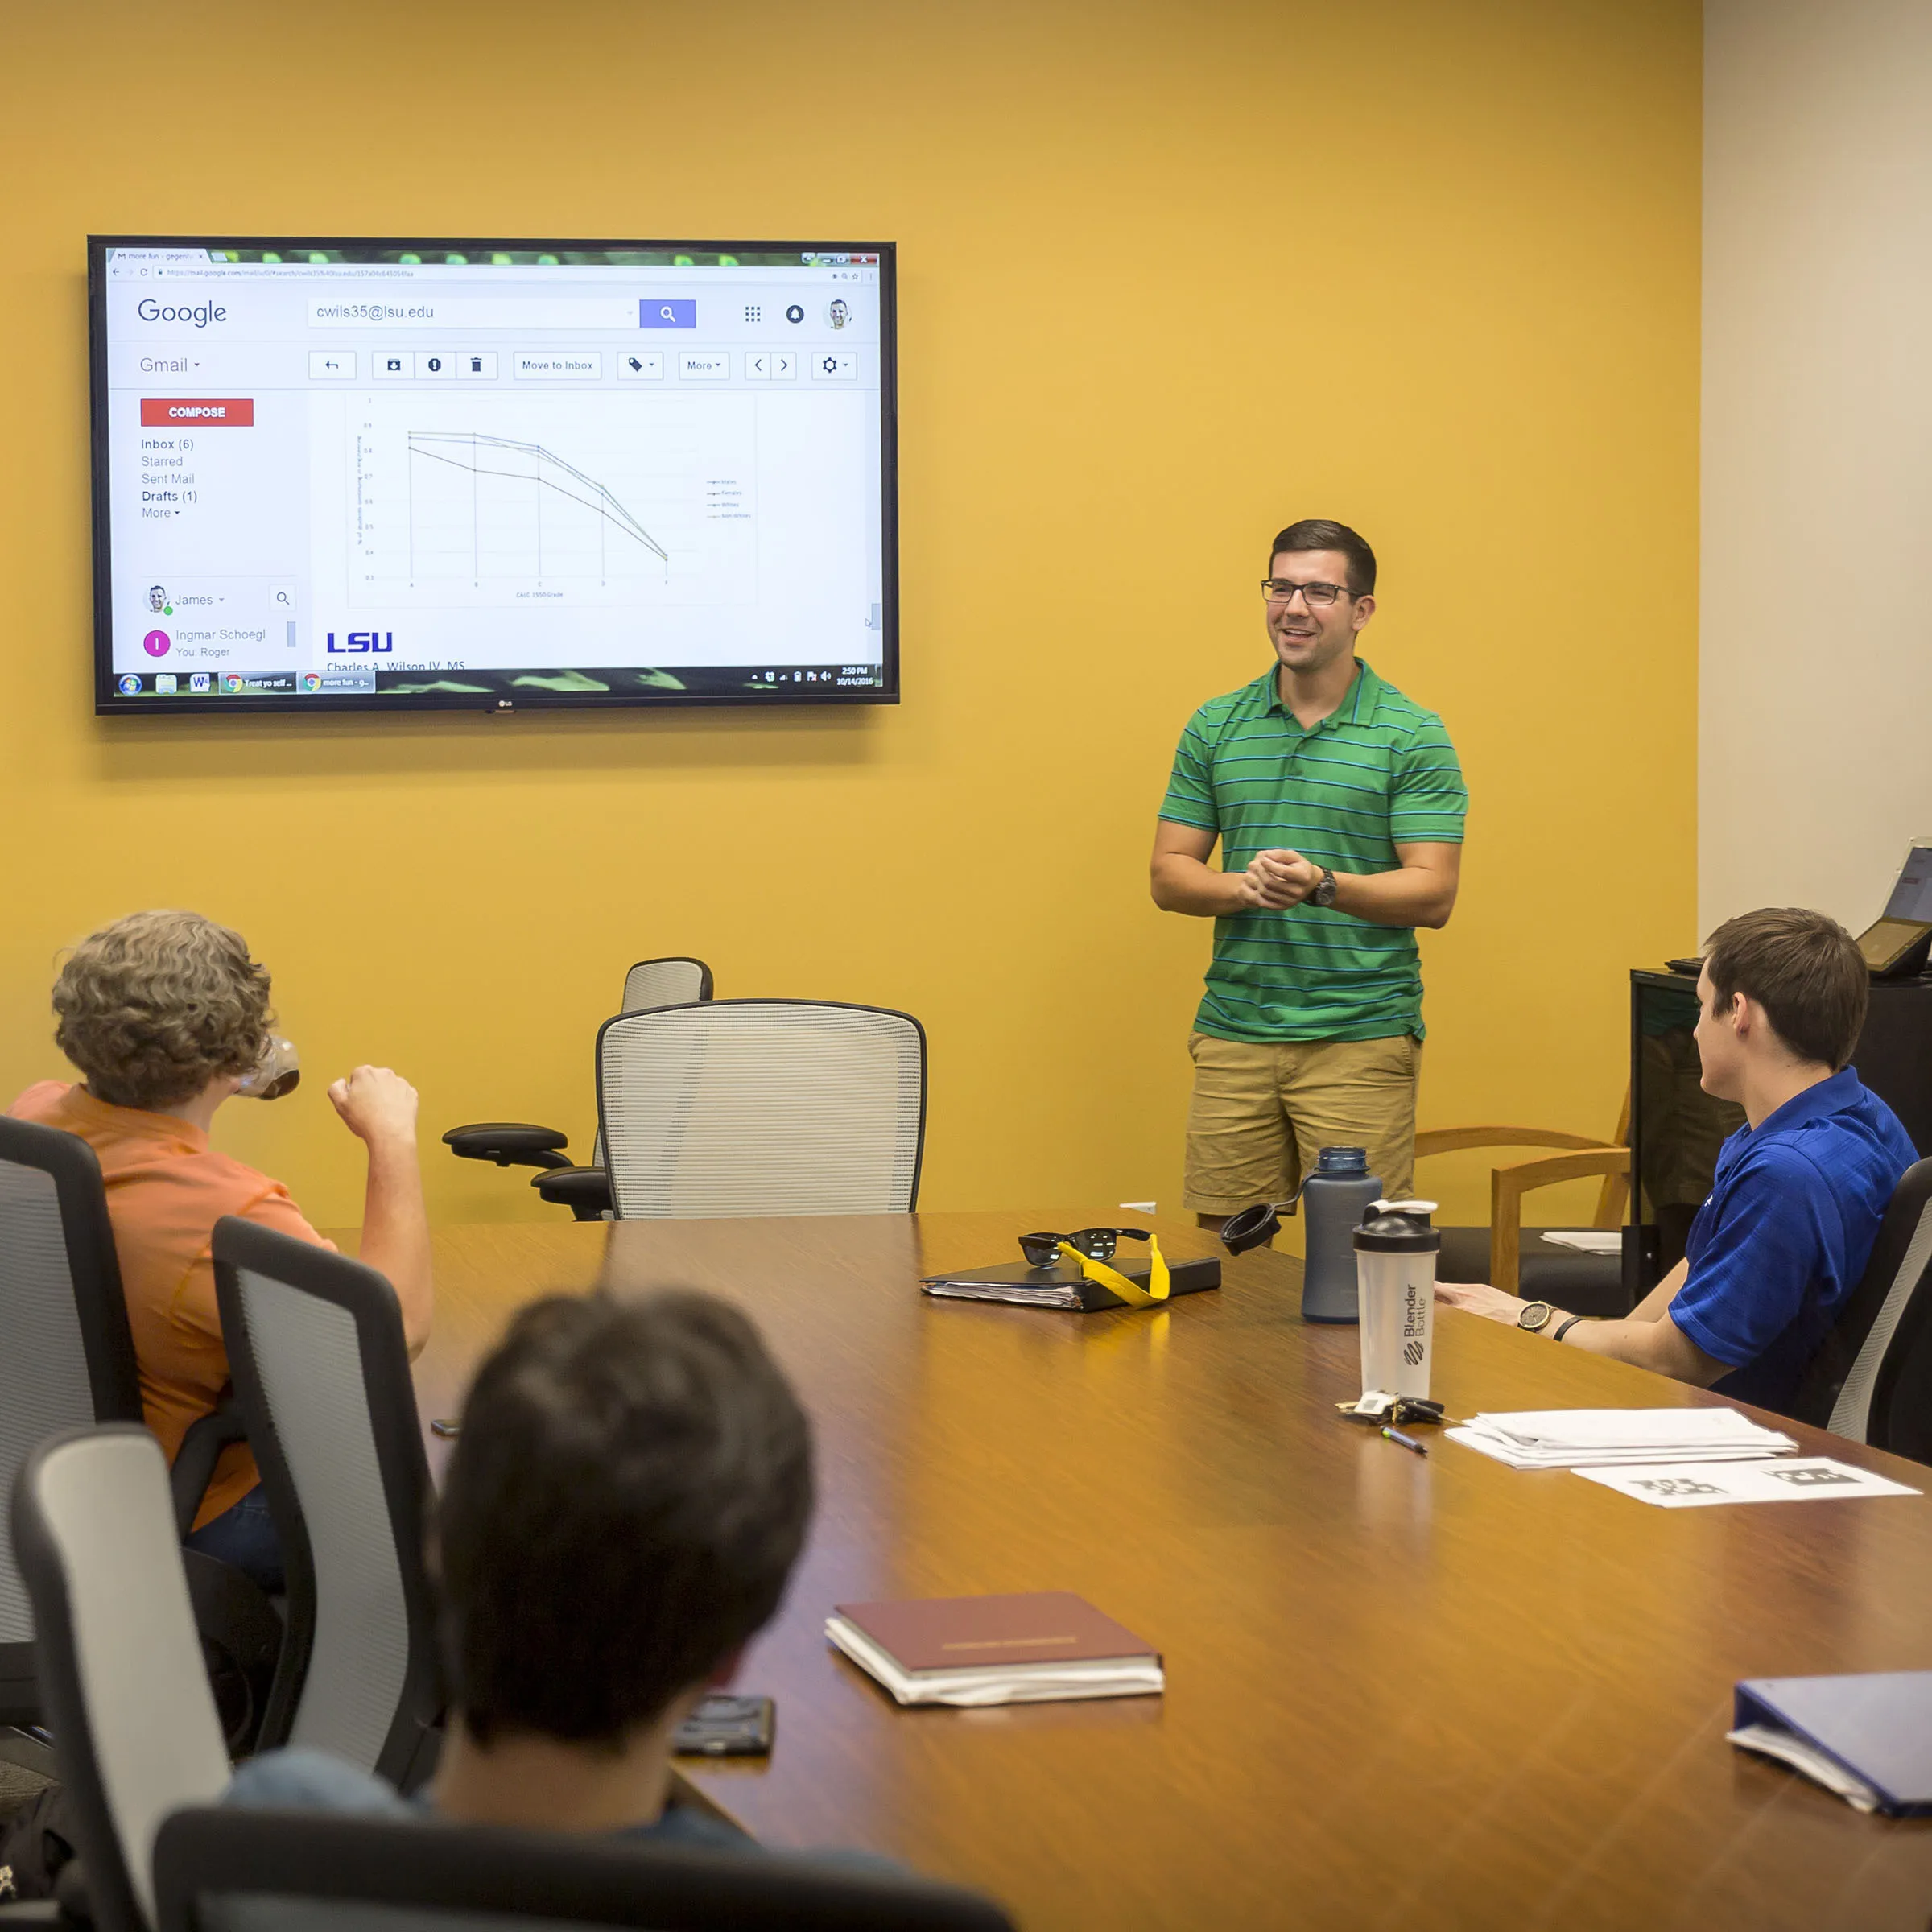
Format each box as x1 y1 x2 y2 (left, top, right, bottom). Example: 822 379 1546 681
10 912 431 1590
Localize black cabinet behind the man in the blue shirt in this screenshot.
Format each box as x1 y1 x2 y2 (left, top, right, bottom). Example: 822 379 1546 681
1624 968 1932 1296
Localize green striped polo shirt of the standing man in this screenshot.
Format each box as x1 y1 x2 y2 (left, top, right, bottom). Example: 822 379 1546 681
1161 663 1468 1039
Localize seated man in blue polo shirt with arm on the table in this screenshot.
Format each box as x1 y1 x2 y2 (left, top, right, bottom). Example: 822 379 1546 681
1435 910 1918 1412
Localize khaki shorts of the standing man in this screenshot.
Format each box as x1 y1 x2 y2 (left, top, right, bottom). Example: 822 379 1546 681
1183 1034 1422 1213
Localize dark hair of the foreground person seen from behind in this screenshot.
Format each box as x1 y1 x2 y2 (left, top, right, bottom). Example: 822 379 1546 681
439 1290 811 1750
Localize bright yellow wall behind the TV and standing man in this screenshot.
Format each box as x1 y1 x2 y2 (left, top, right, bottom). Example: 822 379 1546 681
0 0 1700 1223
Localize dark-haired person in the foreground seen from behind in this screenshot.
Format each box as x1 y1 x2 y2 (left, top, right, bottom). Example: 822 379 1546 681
228 1290 813 1847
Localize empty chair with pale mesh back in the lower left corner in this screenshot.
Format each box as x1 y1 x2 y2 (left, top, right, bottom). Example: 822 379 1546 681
11 1422 228 1932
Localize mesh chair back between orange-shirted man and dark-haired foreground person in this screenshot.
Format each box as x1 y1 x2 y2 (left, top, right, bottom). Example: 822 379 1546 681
214 1216 443 1789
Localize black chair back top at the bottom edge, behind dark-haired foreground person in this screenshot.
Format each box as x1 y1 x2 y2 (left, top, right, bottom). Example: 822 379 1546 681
155 1808 1014 1932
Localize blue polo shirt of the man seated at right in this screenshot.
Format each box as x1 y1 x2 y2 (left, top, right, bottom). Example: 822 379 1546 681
1671 1067 1918 1412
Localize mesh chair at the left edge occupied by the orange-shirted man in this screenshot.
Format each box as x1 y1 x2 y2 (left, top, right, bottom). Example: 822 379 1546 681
0 1119 282 1748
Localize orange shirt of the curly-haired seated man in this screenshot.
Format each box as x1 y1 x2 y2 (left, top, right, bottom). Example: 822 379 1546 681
8 1080 334 1530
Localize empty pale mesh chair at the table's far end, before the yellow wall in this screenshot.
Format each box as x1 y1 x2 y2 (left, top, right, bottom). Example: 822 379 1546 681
597 999 926 1221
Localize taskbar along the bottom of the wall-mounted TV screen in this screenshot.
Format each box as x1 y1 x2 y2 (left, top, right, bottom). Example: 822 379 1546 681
114 665 885 707
